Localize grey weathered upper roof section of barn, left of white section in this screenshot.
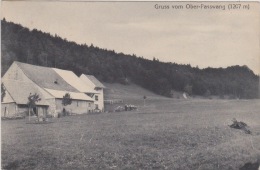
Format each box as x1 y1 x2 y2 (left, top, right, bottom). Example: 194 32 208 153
15 61 79 92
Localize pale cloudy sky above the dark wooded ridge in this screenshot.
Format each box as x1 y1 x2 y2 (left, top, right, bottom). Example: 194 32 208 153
1 1 260 74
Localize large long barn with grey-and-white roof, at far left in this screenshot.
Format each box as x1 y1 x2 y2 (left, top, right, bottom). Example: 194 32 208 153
1 61 97 116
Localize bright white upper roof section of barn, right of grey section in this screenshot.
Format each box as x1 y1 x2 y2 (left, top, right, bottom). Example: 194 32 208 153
53 68 97 93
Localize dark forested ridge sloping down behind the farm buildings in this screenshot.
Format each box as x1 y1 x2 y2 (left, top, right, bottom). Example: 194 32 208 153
1 19 259 98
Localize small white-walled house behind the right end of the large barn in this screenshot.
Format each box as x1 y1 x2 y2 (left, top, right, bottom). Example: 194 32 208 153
80 74 106 111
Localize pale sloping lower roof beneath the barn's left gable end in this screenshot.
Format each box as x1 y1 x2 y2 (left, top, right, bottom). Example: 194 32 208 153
2 79 49 105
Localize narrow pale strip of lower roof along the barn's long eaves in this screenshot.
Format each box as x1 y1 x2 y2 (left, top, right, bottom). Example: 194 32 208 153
45 88 94 101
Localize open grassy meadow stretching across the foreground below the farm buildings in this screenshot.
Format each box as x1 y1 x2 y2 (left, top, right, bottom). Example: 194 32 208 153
1 99 260 170
